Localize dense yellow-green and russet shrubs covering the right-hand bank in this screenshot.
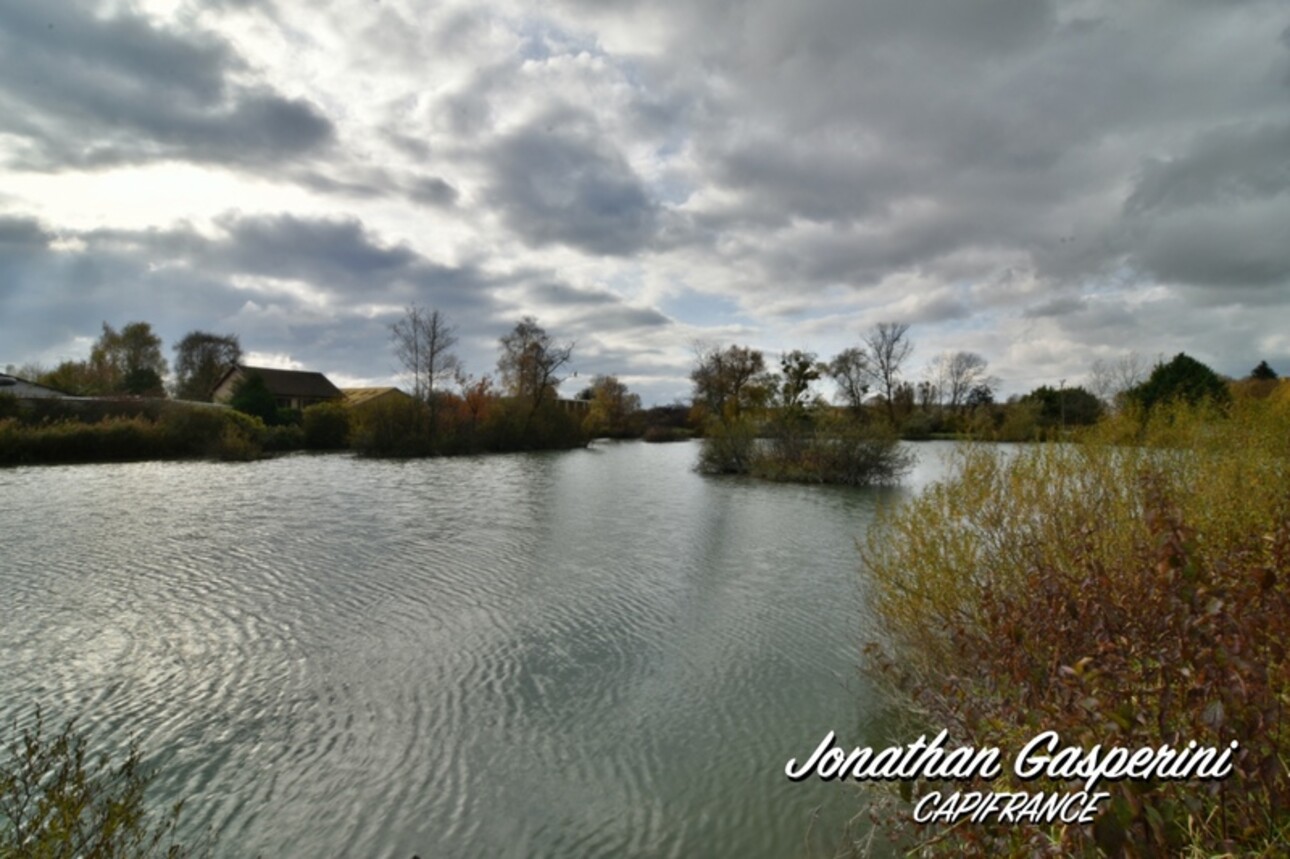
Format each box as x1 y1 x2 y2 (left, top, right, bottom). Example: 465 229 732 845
863 397 1290 856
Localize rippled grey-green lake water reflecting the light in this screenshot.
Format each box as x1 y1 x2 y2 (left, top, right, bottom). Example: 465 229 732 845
0 442 949 859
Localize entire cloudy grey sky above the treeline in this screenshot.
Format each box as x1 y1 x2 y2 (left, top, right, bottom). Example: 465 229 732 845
0 0 1290 402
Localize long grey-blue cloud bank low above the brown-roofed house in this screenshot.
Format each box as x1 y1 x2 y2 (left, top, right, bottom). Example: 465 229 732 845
0 214 498 377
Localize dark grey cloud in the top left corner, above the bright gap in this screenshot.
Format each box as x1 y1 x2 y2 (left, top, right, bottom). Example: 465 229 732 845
0 0 333 170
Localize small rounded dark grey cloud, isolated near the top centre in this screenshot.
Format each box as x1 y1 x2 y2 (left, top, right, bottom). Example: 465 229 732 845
485 110 657 255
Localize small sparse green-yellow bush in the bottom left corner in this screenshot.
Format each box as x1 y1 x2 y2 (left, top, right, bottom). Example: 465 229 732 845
0 711 208 859
